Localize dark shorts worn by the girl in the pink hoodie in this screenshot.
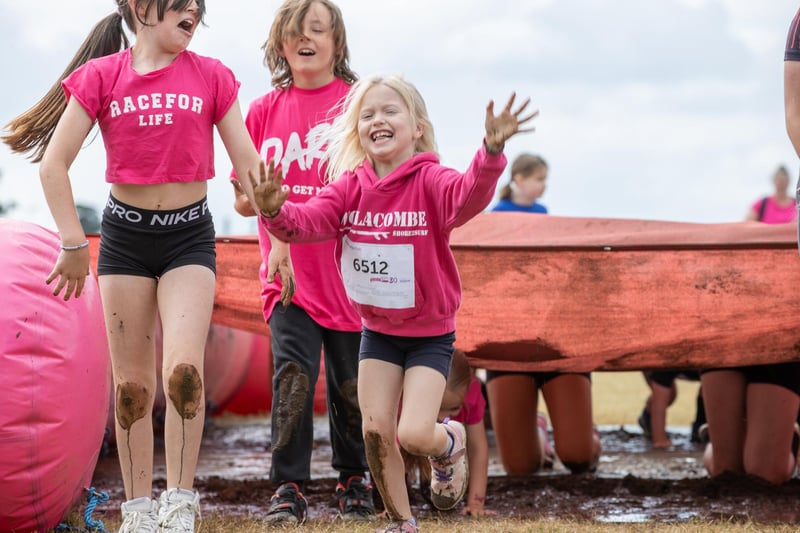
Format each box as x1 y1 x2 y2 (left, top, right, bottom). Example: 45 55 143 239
358 328 456 379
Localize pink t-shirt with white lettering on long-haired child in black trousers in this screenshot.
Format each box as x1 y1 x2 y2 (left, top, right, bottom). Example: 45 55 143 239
245 78 361 331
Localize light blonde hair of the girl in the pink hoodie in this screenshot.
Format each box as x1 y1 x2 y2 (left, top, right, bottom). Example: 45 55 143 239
326 74 437 182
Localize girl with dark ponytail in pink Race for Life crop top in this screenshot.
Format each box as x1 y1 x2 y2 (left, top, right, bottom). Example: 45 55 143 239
4 0 290 532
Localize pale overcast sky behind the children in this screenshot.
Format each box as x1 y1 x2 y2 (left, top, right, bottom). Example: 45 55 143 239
0 0 800 234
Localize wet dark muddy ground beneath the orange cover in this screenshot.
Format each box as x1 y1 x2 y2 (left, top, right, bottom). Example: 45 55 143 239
87 417 800 524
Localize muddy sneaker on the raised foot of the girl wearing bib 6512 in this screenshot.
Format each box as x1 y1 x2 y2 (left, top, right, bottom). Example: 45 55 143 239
428 420 468 511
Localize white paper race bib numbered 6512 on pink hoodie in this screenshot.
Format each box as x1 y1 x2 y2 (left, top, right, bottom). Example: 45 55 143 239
342 236 414 309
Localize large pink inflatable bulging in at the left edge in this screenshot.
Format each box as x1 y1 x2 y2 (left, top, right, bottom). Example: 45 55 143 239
0 219 110 533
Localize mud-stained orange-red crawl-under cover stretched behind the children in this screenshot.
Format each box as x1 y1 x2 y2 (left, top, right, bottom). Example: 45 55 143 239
92 213 800 371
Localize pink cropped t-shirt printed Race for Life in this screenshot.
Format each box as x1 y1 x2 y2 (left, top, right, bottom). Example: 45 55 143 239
62 48 239 185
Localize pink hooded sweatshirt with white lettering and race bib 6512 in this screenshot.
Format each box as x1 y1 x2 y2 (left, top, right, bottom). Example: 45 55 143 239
259 146 506 337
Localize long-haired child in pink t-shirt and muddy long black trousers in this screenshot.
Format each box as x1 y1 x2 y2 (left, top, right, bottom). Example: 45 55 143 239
232 0 375 525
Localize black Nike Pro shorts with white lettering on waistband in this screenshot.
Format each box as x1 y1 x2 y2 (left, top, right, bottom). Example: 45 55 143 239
97 196 217 278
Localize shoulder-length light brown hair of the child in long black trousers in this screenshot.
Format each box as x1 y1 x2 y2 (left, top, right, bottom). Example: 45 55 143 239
261 0 358 89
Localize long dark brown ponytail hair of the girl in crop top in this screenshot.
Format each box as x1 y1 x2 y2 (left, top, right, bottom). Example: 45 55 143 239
3 0 206 163
